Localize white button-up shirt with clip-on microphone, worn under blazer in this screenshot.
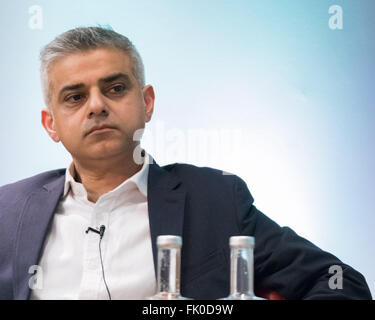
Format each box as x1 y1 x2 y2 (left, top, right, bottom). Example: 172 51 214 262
30 153 156 300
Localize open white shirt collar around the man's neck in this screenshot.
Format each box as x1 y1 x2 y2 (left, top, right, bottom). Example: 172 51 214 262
63 152 152 197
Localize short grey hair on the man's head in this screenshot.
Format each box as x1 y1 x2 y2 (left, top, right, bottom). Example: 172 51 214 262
40 26 145 107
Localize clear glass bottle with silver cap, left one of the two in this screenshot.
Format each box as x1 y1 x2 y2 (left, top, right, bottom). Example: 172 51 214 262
148 235 191 300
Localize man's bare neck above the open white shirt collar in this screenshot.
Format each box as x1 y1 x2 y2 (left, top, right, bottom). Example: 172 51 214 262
70 155 142 203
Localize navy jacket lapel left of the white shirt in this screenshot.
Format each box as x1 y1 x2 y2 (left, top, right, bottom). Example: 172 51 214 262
13 175 65 300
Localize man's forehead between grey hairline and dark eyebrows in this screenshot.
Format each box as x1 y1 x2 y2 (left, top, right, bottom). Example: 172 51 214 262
48 48 133 92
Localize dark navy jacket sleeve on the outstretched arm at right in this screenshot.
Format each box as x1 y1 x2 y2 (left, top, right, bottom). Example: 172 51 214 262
234 178 372 299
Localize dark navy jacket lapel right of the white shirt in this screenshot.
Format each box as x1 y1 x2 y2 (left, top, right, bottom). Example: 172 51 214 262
147 162 186 274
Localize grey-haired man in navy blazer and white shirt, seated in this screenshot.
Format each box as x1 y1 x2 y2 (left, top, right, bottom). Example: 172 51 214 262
0 27 371 299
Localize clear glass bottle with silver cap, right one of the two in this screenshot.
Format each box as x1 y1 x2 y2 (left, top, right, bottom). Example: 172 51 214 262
220 236 265 300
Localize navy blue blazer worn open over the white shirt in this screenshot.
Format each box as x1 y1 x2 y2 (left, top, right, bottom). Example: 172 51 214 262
0 163 371 300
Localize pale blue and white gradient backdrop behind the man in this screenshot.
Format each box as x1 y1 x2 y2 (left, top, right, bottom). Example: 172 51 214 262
0 0 375 296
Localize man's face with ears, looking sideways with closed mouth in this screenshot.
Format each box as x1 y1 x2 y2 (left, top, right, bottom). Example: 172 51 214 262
42 49 155 160
